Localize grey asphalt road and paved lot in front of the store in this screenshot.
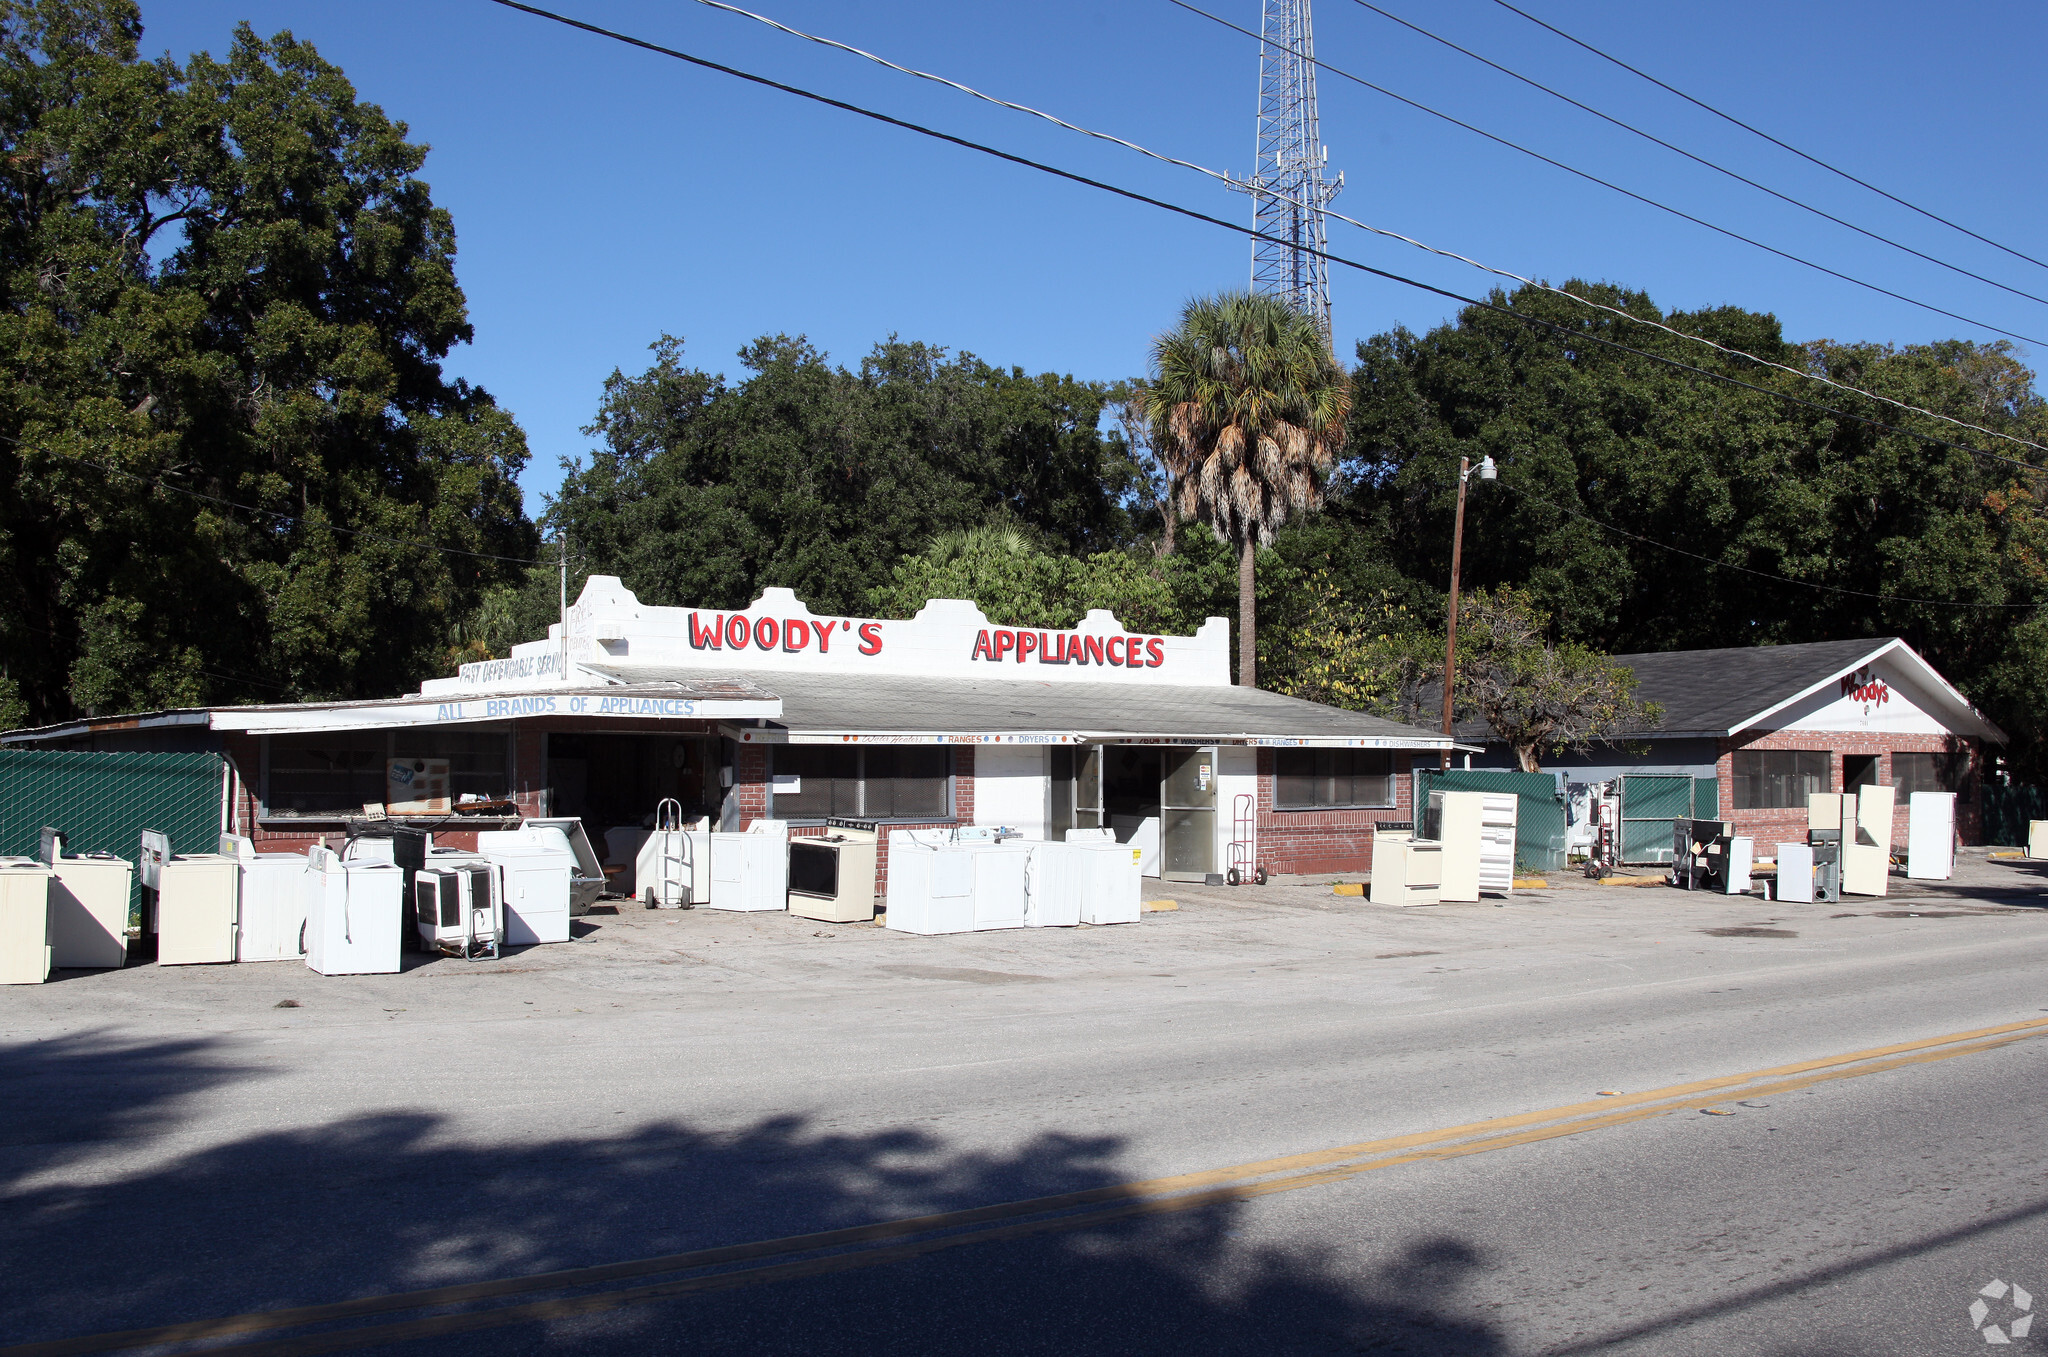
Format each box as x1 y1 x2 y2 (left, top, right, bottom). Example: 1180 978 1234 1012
0 858 2048 1357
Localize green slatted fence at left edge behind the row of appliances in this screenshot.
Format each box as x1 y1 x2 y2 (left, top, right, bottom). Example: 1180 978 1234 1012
0 749 221 925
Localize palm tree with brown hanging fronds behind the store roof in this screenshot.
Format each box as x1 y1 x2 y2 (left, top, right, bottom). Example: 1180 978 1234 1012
1147 293 1352 688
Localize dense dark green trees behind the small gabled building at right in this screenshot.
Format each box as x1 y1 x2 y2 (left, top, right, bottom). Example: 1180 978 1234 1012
1341 284 2048 776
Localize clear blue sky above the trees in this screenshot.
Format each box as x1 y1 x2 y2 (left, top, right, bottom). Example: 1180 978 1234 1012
143 0 2048 514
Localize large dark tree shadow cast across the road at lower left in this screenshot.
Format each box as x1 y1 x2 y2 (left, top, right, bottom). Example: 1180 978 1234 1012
0 1036 1505 1357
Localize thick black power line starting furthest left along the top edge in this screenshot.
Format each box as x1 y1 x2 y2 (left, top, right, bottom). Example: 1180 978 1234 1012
489 0 2048 493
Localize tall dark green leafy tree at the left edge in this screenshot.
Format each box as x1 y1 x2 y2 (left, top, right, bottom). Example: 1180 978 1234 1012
0 0 532 725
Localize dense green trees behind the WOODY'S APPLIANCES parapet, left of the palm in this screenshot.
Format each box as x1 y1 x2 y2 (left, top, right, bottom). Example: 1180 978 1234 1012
535 336 1133 630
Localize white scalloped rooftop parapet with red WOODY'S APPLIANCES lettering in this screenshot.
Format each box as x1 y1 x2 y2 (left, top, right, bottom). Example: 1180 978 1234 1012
428 575 1231 692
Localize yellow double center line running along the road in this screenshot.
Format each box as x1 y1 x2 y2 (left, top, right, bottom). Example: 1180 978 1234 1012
16 1017 2048 1357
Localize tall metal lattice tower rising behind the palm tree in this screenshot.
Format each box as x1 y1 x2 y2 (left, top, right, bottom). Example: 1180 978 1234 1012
1233 0 1343 342
